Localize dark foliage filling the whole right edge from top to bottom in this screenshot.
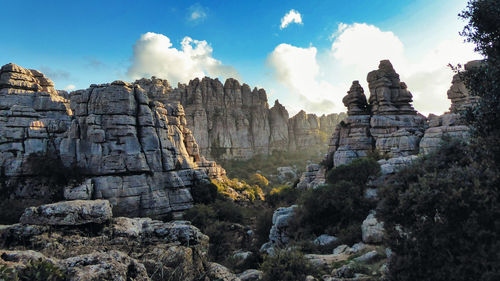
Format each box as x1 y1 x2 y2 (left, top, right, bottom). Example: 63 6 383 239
378 0 500 281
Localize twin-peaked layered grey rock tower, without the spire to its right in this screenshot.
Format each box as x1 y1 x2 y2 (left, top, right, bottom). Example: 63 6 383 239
329 60 426 166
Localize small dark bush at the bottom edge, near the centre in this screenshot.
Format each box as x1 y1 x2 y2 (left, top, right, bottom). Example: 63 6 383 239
261 250 319 281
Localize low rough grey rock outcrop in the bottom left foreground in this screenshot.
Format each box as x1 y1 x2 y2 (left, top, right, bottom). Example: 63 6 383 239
0 201 223 280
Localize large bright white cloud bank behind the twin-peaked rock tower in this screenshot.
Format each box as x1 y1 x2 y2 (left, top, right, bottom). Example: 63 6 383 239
268 23 480 114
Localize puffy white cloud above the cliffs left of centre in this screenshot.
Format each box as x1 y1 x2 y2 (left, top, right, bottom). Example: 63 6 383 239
127 32 239 85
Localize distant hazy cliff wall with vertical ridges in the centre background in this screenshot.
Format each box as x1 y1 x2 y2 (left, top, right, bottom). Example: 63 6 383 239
136 77 344 159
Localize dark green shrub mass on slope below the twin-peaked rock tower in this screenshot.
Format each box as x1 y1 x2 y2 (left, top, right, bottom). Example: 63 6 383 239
292 158 380 245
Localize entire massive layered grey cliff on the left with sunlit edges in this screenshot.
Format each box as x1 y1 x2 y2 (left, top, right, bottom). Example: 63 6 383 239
0 64 225 216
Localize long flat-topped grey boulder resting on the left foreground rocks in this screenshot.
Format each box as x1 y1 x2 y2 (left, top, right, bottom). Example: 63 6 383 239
20 200 113 225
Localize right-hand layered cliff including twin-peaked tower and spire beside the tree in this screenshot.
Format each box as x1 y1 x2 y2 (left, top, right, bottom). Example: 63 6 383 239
328 61 480 166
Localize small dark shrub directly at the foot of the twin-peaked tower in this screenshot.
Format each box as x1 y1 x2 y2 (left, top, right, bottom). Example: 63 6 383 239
326 158 380 185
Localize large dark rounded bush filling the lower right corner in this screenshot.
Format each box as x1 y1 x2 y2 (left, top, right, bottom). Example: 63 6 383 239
377 138 500 281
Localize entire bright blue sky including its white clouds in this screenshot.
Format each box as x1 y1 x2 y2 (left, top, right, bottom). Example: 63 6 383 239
0 0 479 113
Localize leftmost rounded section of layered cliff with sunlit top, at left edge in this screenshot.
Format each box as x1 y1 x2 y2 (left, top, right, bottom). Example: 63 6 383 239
0 63 72 177
